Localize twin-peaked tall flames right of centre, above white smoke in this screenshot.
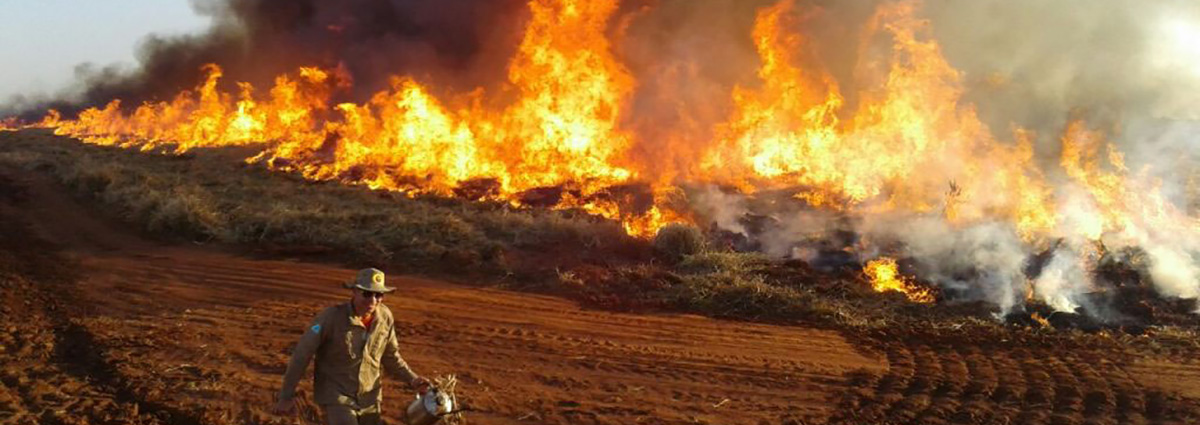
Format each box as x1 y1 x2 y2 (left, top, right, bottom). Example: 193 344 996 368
706 1 1052 235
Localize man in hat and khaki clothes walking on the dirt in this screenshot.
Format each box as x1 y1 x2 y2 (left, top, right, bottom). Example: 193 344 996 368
274 269 430 425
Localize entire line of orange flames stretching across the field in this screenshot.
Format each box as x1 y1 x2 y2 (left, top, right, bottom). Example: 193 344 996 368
18 0 1200 307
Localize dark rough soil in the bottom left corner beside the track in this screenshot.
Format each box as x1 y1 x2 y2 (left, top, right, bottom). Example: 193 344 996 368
0 168 207 425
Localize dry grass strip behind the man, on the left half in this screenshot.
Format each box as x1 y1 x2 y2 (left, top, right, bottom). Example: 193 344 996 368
0 131 629 275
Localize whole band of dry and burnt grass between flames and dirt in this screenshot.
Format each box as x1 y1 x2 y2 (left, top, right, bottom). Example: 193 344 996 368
0 130 1200 355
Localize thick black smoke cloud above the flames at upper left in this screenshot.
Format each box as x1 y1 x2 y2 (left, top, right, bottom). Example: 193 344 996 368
0 0 528 121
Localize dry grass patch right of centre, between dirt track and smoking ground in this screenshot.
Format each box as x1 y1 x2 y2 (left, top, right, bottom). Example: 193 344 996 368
557 247 934 331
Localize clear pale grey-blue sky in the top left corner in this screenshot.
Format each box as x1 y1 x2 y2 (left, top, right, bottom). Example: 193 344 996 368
0 0 209 104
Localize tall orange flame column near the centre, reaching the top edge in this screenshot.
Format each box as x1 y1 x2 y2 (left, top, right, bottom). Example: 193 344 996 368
502 0 634 187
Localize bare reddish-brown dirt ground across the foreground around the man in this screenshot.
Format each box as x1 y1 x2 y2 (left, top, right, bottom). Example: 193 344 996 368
0 157 1200 425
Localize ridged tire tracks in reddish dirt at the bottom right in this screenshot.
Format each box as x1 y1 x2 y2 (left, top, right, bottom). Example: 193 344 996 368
833 342 1200 425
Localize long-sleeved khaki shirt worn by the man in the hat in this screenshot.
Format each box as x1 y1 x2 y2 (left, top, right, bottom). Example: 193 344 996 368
280 303 416 408
